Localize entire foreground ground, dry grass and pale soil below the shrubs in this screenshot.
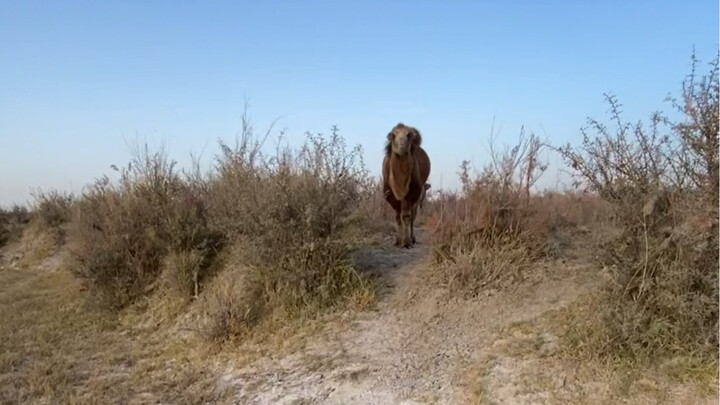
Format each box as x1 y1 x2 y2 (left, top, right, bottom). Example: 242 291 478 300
0 229 718 405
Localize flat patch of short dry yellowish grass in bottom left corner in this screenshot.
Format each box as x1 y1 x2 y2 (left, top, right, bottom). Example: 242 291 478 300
0 258 231 404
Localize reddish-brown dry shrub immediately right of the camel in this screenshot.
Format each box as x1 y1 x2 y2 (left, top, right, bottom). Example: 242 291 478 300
427 126 611 296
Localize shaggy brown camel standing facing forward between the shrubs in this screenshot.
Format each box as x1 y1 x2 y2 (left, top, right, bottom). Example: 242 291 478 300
382 123 430 248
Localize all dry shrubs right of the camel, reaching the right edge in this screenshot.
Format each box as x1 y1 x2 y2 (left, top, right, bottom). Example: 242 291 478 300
420 50 720 398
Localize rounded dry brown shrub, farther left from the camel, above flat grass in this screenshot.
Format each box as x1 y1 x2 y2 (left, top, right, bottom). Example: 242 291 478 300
69 146 219 308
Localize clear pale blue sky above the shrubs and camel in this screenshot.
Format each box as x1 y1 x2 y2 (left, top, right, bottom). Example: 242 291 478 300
0 0 719 205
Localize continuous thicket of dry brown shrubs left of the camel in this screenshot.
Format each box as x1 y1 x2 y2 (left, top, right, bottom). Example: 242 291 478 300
70 111 374 336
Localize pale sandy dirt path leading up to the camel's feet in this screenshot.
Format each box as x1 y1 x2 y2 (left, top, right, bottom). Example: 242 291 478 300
227 230 596 405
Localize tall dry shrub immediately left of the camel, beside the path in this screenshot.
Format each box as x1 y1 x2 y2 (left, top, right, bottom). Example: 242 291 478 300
210 124 372 329
